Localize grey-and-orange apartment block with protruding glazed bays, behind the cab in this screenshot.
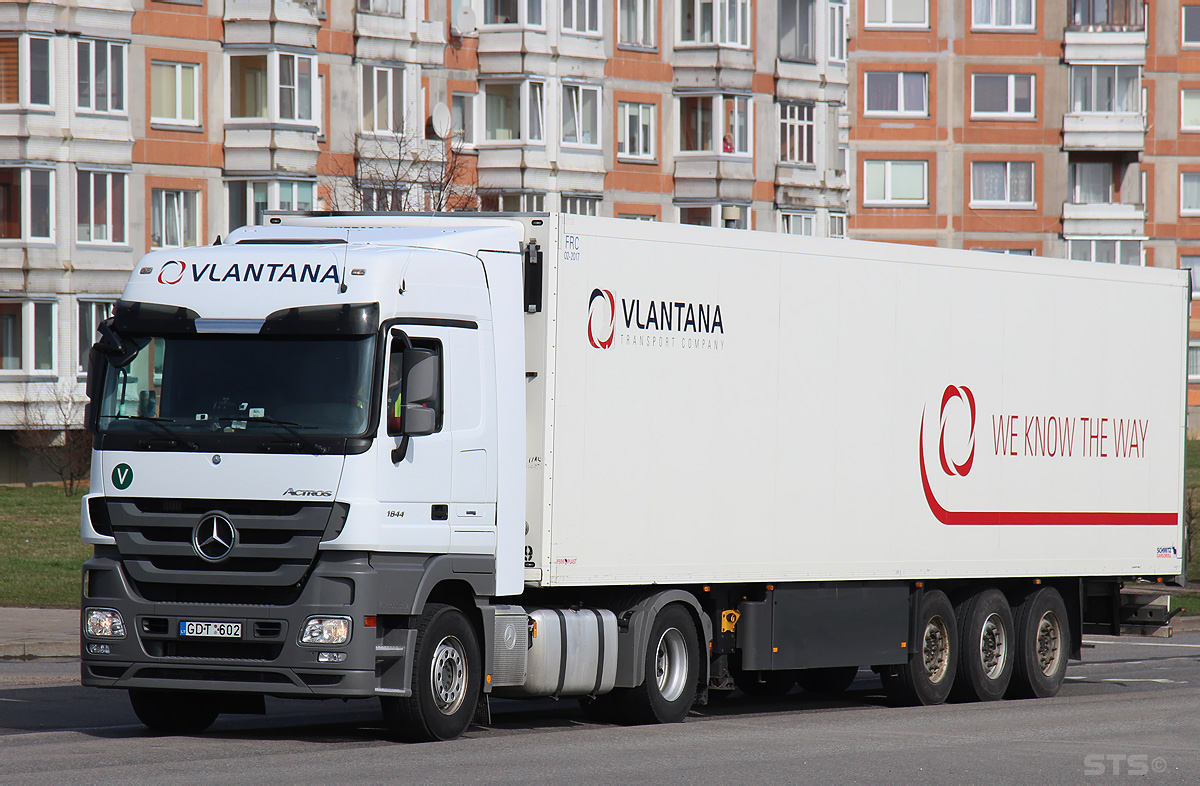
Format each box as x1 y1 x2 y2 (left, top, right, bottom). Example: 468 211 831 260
0 0 857 482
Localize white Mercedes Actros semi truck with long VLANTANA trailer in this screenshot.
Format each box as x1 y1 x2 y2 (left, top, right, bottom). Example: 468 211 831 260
80 212 1190 740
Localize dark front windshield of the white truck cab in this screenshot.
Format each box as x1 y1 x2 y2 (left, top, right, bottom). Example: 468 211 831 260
98 334 376 438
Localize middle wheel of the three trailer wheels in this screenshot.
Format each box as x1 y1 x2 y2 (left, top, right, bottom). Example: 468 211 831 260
950 587 1016 701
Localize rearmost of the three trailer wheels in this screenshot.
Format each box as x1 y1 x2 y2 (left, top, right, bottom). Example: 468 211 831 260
1008 587 1070 698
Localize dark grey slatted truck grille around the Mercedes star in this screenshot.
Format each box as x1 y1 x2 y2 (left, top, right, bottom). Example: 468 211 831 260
106 498 349 604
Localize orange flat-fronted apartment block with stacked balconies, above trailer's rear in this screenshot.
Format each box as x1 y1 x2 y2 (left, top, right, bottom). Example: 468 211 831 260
848 0 1200 428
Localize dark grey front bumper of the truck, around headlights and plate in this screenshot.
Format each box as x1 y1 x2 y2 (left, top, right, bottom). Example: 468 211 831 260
80 552 379 698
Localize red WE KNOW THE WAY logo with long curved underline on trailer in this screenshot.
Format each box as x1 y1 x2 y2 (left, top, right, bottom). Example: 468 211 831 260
918 385 1178 527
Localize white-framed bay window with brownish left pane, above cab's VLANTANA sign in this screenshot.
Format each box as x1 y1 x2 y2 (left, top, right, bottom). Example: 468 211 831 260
229 52 317 121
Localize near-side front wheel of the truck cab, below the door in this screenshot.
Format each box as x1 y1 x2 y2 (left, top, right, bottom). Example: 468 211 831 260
379 604 482 743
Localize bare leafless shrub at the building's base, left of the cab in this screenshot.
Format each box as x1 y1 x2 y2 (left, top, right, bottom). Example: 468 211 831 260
13 384 91 497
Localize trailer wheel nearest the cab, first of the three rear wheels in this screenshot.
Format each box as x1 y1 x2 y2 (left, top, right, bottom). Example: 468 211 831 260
883 589 959 706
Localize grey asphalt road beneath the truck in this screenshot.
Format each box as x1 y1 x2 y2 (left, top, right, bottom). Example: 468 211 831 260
0 634 1200 784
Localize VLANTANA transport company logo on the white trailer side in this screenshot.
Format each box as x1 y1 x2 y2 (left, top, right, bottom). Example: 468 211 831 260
588 288 725 350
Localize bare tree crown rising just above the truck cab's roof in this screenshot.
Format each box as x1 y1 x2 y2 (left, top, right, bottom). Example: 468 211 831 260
328 134 479 212
